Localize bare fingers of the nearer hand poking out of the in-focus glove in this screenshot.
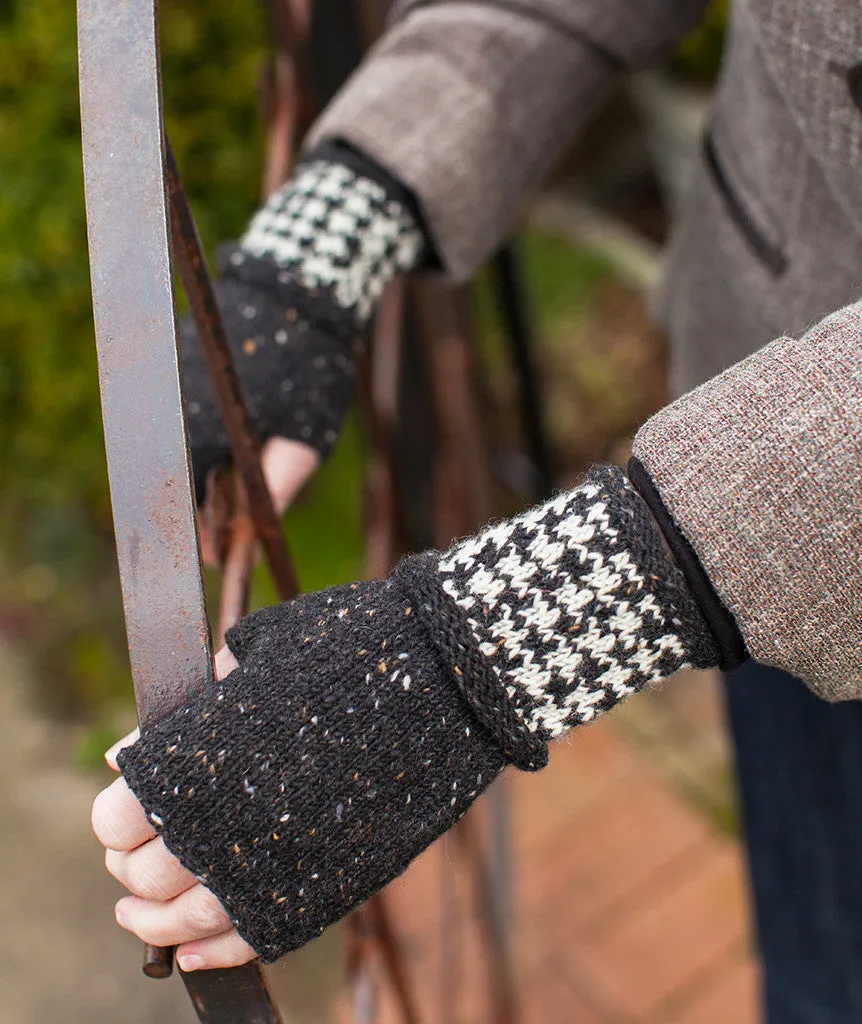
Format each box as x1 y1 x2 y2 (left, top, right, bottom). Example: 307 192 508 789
92 647 256 971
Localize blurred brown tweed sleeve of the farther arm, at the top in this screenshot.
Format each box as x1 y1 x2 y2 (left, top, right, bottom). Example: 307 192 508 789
309 0 706 279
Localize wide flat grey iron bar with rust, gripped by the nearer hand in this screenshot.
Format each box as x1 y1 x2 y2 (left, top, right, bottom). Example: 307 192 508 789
78 0 278 1011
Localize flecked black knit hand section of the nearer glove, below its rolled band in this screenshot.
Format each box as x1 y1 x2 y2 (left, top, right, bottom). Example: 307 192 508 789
119 581 506 963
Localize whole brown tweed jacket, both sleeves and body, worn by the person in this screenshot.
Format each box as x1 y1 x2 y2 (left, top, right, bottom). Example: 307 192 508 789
312 0 862 699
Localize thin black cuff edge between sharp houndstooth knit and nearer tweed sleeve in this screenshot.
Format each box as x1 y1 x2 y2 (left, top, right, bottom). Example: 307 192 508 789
628 457 748 672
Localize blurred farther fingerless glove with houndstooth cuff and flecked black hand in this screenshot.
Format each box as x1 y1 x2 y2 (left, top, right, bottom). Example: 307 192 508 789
180 145 425 502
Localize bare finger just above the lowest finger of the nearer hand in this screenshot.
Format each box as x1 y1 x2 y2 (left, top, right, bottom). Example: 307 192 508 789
115 883 233 946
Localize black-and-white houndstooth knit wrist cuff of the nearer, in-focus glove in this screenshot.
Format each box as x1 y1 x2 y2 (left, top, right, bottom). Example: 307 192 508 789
438 467 718 739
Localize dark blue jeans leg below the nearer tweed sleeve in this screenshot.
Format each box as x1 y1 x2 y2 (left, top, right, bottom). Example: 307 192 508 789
726 662 862 1024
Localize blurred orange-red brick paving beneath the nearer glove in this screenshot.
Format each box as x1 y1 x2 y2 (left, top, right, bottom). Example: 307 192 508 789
366 716 760 1024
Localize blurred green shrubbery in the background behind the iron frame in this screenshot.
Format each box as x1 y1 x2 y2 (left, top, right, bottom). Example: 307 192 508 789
0 0 726 749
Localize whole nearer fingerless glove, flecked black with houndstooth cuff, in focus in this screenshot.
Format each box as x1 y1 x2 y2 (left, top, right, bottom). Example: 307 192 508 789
119 468 719 962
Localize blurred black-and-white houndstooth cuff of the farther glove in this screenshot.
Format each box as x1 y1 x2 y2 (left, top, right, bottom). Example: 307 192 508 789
236 160 425 324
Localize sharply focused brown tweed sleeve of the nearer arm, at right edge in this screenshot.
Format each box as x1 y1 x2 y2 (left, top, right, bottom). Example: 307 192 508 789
634 302 862 700
